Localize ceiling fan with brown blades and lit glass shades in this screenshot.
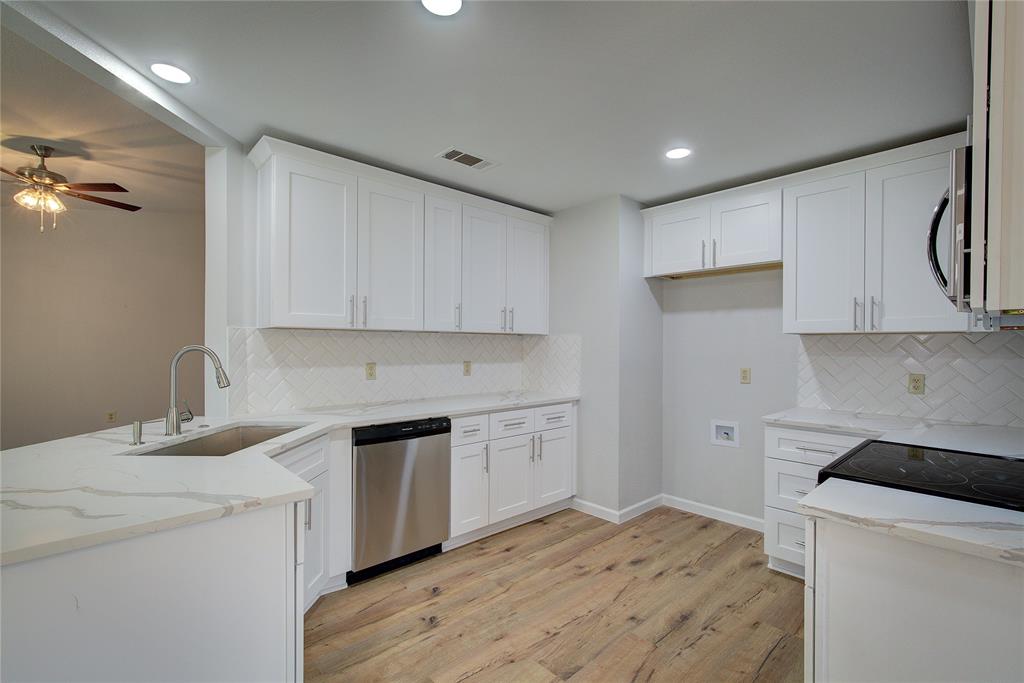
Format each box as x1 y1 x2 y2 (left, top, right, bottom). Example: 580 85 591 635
0 144 142 231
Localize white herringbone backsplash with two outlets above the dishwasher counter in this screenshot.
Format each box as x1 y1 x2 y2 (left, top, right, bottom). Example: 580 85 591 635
228 328 581 415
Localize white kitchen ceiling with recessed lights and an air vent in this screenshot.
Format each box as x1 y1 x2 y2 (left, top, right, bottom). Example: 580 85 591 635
39 0 971 212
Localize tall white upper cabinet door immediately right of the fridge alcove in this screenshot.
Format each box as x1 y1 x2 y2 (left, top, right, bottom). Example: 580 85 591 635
782 173 864 333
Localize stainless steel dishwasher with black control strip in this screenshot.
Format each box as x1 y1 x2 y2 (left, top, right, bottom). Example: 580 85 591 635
347 418 452 584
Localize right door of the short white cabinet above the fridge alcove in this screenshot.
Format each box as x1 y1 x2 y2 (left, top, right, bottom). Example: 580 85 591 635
710 189 782 268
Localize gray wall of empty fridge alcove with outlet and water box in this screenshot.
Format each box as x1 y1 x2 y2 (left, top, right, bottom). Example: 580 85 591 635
663 270 799 519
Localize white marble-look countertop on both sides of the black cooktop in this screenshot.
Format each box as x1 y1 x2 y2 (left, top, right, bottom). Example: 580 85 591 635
763 408 1024 566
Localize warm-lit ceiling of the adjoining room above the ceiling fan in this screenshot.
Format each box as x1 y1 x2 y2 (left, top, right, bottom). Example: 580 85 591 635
0 30 205 216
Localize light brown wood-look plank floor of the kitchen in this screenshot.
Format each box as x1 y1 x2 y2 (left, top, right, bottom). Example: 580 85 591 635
305 508 804 683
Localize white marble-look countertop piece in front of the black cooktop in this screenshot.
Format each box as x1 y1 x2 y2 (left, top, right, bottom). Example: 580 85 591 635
798 478 1024 567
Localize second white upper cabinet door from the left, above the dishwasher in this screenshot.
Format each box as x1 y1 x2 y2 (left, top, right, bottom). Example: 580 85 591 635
357 178 423 330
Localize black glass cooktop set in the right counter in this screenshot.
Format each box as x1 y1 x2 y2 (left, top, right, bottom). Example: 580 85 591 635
818 441 1024 511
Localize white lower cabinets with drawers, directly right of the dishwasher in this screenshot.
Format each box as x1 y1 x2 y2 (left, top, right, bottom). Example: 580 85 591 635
451 403 575 543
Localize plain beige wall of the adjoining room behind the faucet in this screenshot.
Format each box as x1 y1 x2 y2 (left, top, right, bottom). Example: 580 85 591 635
0 204 204 449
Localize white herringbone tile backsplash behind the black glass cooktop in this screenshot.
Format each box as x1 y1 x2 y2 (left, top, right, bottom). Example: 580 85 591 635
798 332 1024 427
